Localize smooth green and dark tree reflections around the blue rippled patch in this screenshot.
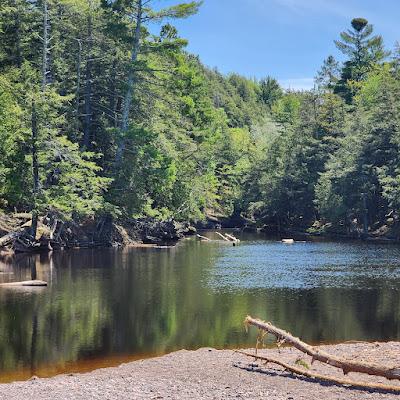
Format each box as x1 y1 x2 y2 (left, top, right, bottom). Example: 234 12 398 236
0 242 400 372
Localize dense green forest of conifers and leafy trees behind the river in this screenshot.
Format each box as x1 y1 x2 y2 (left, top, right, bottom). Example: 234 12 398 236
0 0 400 236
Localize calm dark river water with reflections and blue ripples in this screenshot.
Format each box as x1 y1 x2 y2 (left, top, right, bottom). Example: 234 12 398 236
0 233 400 382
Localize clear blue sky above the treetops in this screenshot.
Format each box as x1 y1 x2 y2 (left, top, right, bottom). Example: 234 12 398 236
160 0 400 89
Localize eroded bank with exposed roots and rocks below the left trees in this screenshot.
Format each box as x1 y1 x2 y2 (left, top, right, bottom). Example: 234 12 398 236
0 214 196 252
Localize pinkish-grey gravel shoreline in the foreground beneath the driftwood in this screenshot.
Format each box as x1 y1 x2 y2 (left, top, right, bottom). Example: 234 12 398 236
0 342 400 400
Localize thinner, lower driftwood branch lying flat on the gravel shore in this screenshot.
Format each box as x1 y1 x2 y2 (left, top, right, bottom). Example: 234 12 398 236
236 350 400 393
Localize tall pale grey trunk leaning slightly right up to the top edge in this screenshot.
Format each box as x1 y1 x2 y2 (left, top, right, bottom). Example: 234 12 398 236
115 0 143 165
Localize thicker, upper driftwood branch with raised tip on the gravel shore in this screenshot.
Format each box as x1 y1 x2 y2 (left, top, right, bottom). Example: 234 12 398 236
245 316 400 379
